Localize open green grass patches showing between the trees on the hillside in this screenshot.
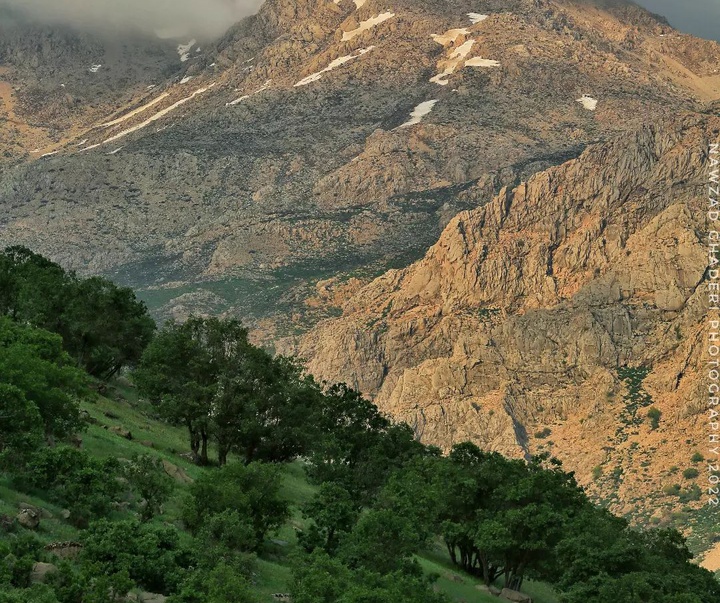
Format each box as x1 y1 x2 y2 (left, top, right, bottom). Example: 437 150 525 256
0 382 558 603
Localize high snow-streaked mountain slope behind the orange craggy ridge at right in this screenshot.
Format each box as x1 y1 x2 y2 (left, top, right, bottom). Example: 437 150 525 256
0 0 720 330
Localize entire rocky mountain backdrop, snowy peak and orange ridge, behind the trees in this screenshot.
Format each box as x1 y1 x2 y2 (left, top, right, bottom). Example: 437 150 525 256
0 0 720 560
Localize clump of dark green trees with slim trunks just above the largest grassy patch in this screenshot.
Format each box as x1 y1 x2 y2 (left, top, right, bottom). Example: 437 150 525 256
135 318 316 465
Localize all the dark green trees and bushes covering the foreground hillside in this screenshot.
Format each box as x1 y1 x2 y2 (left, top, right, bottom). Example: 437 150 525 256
0 248 720 603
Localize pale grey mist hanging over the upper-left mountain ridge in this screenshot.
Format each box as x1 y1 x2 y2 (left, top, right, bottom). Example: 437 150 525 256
0 0 262 37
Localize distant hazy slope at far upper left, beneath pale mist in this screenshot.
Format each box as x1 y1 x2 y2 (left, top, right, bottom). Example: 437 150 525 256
0 7 182 164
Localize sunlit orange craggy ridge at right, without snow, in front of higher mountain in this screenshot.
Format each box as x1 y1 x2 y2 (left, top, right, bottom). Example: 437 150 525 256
298 107 720 545
